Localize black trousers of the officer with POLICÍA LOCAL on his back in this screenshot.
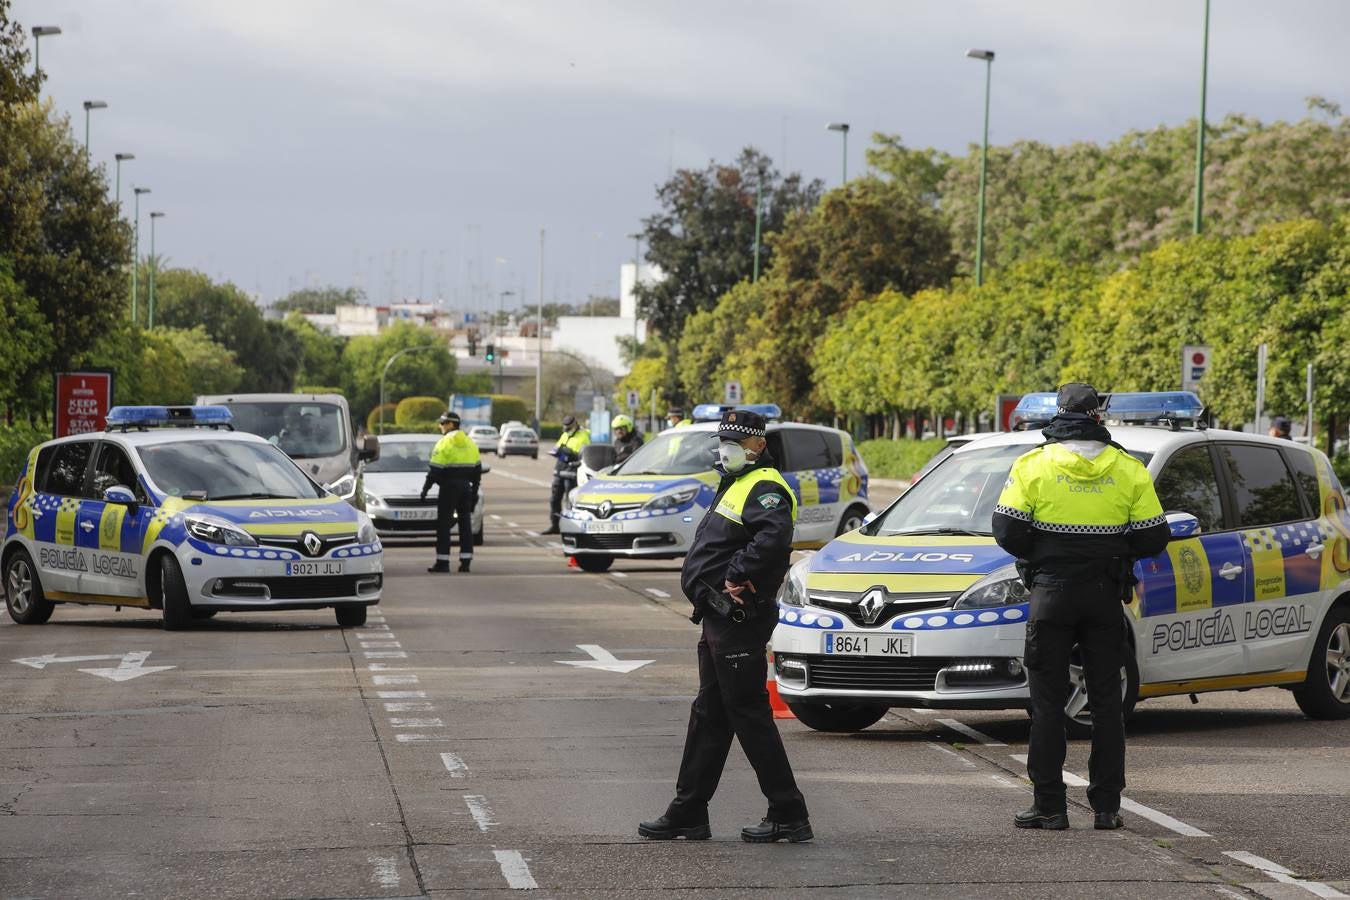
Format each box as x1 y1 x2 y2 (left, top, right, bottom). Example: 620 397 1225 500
1026 580 1127 812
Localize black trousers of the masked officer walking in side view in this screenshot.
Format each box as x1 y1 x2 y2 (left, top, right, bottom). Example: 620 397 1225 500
666 609 806 822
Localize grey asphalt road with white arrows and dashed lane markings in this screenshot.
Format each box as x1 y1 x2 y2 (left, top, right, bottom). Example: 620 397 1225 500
0 457 1350 900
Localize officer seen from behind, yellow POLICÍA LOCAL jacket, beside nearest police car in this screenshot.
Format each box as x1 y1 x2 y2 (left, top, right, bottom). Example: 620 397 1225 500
994 383 1169 830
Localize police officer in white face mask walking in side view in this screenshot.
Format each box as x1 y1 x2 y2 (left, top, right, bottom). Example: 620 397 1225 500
637 410 814 843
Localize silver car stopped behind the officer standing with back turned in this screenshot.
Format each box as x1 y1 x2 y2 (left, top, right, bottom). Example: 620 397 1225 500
363 434 490 545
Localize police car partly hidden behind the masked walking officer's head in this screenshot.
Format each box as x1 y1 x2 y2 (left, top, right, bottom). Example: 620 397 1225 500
559 403 871 572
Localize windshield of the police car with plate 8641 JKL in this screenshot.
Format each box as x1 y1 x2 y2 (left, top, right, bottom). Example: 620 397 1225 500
864 444 1153 537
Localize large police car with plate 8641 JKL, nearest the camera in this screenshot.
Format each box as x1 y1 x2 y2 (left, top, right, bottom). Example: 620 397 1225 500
772 393 1350 731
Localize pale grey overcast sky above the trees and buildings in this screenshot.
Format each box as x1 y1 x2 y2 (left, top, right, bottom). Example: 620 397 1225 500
12 0 1350 315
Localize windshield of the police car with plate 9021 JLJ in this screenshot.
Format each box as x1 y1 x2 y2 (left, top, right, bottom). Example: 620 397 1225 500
136 437 324 501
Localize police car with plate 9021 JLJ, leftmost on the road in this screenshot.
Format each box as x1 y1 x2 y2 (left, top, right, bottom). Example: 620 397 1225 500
0 406 383 629
